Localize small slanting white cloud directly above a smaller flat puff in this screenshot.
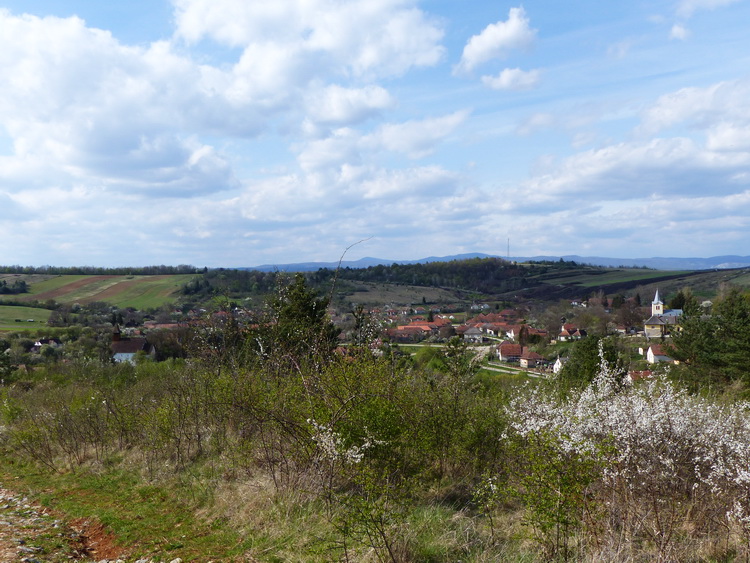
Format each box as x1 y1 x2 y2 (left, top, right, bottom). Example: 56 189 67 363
454 7 536 74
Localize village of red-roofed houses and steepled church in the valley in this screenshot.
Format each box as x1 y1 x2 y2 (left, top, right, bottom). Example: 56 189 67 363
6 290 688 377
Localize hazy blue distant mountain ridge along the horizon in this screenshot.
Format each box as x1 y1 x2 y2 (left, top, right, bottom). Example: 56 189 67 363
244 252 750 272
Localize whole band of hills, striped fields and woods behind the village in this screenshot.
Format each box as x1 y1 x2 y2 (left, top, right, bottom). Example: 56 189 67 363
0 257 750 312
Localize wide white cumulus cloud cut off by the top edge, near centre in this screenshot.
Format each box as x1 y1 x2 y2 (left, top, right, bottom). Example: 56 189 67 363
173 0 443 76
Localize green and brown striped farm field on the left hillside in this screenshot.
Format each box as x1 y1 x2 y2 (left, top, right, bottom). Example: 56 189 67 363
1 274 194 309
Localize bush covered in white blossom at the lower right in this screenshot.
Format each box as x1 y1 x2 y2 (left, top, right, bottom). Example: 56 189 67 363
508 344 750 559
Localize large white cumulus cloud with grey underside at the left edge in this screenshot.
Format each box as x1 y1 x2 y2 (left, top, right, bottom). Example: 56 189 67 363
0 12 247 196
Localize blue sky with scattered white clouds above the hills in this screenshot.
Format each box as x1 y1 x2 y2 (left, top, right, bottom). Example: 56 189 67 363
0 0 750 267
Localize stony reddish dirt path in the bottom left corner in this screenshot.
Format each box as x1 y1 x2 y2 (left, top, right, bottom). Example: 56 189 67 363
0 488 121 563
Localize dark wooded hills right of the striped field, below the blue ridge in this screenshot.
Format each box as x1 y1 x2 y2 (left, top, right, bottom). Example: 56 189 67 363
192 257 750 306
